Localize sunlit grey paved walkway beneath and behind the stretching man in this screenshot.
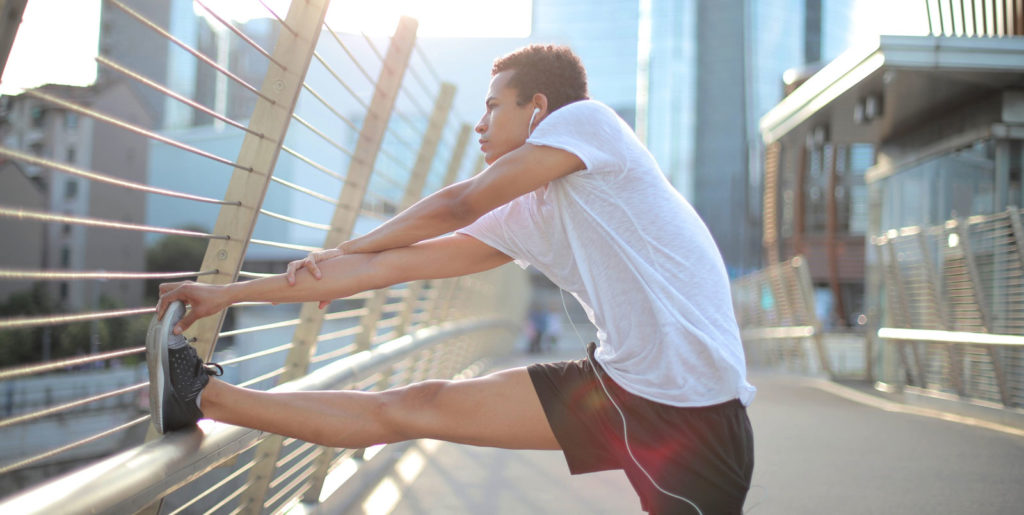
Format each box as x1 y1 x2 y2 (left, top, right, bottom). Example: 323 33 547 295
346 349 1024 514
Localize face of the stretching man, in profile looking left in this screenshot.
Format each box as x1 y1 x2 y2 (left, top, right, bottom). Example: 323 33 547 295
476 70 535 165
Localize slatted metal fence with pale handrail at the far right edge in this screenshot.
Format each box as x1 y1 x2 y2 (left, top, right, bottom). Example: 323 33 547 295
873 208 1024 407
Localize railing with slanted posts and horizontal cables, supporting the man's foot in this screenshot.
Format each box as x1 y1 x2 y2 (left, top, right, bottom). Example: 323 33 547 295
0 0 528 513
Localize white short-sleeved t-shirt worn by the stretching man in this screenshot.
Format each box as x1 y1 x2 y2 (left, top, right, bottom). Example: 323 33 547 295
459 100 755 406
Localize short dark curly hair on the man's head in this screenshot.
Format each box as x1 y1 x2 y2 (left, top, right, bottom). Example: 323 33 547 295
490 45 589 113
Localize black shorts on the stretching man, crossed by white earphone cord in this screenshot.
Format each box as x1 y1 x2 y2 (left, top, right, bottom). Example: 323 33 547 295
527 344 754 515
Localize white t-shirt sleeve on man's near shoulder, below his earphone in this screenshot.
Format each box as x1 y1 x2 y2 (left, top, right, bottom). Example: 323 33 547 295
526 100 633 172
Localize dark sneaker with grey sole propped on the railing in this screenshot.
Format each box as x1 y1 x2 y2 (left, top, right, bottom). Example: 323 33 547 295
145 302 224 434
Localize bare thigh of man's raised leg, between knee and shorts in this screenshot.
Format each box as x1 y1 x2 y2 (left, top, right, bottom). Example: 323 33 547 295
395 368 561 450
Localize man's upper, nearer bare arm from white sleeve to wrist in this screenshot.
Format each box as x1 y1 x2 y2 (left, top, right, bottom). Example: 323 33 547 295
338 144 585 254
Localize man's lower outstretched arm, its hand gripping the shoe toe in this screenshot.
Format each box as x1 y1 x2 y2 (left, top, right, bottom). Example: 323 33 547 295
157 234 512 334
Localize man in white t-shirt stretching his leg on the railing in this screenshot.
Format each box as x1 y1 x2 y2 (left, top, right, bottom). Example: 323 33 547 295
148 45 755 514
